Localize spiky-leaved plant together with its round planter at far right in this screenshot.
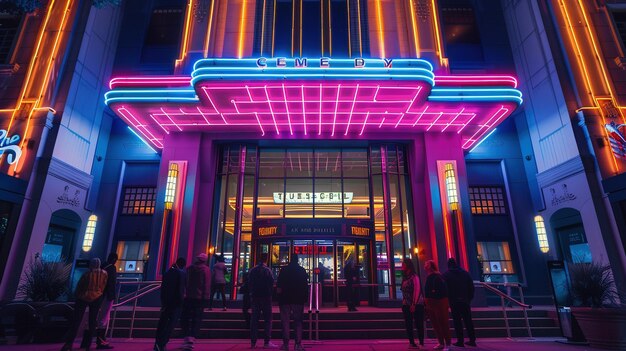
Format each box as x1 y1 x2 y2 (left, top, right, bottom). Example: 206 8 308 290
568 262 626 350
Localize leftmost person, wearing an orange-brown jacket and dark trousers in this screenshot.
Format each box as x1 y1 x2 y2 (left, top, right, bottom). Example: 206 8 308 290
61 258 107 351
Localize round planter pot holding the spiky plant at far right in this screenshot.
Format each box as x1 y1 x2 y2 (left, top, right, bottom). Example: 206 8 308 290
572 307 626 350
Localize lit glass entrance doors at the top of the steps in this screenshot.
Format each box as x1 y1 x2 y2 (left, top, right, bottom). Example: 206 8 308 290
258 238 375 307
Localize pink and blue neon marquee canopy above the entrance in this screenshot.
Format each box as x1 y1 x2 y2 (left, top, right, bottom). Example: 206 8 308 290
105 57 522 149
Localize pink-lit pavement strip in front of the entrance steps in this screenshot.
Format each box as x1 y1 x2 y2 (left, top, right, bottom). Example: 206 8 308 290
0 338 597 351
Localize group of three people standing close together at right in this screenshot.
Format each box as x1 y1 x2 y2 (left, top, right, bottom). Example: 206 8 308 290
401 258 476 350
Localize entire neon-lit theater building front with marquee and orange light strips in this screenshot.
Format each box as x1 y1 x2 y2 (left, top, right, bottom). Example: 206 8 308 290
0 0 626 305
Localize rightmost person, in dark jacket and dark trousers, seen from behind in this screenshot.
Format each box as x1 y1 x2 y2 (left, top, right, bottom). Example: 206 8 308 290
443 258 476 347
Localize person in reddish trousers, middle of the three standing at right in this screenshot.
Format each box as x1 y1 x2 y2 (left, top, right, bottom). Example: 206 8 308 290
424 260 452 350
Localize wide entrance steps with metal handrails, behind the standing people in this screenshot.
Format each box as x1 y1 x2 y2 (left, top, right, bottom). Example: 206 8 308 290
108 306 561 340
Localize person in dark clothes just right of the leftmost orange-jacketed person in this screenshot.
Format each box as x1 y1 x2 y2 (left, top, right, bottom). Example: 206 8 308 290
96 252 118 349
